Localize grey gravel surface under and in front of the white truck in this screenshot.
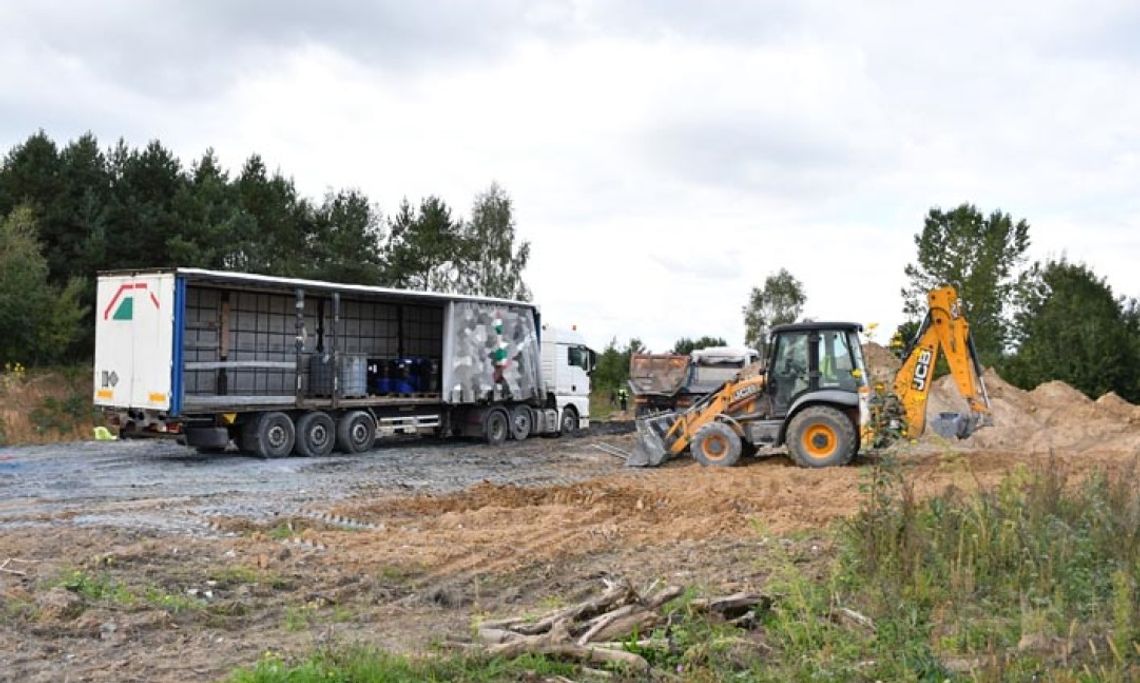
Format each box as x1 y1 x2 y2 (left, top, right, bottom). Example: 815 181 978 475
0 433 622 535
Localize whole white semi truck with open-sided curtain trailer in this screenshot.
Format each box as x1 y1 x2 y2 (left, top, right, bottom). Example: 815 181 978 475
95 268 596 457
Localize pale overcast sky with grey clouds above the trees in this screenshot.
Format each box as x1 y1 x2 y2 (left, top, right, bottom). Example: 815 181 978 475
0 0 1140 350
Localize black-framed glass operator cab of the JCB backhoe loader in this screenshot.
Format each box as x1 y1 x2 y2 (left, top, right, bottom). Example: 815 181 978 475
767 323 868 417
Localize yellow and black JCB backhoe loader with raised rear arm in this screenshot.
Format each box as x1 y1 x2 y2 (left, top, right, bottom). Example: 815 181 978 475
626 286 990 467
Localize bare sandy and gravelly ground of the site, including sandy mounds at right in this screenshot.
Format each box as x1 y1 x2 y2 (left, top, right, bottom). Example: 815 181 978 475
0 360 1140 681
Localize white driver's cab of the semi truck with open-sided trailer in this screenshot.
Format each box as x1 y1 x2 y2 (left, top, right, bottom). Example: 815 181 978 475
542 326 597 432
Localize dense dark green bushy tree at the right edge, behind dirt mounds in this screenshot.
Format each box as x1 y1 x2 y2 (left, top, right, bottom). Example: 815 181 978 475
1002 259 1140 401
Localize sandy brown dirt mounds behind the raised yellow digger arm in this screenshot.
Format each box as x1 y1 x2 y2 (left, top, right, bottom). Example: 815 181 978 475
925 368 1140 453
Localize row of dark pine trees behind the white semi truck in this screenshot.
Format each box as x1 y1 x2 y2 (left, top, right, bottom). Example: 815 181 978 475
0 131 530 365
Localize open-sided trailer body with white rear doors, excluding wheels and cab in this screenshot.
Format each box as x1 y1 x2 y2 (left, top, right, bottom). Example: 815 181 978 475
96 268 560 453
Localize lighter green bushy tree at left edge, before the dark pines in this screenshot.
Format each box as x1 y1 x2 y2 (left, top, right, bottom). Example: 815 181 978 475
0 208 84 364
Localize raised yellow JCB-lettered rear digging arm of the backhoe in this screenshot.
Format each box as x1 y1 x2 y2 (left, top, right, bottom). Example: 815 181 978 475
895 286 991 438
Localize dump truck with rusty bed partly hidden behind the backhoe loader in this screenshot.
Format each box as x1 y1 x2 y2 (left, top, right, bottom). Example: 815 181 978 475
629 347 760 417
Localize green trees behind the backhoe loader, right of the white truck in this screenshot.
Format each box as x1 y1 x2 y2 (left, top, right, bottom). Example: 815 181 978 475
743 204 1140 403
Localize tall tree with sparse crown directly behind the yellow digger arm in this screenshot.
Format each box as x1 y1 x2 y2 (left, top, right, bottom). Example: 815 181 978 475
903 204 1029 365
